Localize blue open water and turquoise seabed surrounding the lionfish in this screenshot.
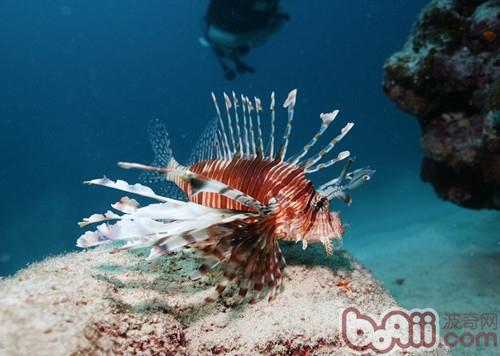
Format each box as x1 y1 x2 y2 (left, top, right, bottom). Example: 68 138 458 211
0 0 500 352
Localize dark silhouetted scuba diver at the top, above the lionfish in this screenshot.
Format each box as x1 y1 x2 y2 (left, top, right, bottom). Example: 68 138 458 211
200 0 290 79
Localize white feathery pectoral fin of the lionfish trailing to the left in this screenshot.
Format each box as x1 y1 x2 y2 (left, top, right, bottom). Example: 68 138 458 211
77 180 252 258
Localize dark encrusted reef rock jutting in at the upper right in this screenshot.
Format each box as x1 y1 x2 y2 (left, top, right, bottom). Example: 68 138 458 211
384 0 500 209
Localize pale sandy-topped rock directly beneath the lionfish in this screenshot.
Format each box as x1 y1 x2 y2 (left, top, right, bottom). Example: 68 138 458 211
0 246 448 355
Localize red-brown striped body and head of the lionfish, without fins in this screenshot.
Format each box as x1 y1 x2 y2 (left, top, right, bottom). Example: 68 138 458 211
172 157 343 248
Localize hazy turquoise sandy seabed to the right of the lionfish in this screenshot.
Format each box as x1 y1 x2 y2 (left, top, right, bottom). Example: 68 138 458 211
345 197 500 356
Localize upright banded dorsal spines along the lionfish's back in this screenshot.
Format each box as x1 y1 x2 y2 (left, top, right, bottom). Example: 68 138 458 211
191 89 364 169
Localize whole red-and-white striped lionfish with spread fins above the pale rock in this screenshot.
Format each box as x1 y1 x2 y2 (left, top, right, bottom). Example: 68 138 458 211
77 89 375 302
